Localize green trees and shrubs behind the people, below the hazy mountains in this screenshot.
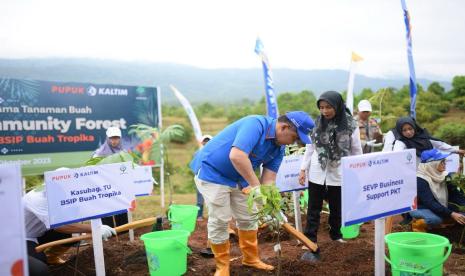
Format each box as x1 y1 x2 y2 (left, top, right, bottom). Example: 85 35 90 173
162 76 465 147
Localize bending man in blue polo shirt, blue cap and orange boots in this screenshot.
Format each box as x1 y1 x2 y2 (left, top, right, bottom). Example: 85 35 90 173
190 111 314 276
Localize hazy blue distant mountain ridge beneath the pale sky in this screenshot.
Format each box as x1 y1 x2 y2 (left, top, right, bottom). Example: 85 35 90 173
0 58 451 103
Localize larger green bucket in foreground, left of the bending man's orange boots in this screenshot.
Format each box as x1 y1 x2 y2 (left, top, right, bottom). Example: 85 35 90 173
140 230 191 276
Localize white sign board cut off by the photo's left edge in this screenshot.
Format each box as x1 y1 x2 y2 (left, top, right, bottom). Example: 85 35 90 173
0 164 28 275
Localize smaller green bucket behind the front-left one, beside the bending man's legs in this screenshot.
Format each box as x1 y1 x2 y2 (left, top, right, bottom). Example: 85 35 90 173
168 204 200 233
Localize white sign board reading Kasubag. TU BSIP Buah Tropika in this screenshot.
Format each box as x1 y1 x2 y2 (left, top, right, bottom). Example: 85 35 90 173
45 162 134 228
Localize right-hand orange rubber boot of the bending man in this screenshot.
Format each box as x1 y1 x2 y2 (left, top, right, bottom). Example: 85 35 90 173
239 229 274 270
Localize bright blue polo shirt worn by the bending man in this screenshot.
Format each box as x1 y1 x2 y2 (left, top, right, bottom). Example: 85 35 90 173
190 115 284 188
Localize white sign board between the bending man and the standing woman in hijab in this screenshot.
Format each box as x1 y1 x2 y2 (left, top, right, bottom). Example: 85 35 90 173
276 155 308 192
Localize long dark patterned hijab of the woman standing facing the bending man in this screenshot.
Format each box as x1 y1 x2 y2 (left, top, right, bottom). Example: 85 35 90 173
311 91 357 170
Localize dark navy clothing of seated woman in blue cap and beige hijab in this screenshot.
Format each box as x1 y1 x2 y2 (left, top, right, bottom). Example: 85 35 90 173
412 177 465 218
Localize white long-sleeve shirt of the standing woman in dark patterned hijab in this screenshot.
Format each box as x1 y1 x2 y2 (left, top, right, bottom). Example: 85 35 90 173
300 127 363 186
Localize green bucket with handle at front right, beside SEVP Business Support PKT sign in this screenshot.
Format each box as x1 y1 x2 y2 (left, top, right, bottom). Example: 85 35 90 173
384 232 452 276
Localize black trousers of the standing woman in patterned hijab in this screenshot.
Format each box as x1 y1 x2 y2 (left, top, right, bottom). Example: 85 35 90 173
304 182 342 242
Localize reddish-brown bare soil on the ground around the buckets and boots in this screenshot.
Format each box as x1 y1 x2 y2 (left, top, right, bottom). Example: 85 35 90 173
51 214 465 276
